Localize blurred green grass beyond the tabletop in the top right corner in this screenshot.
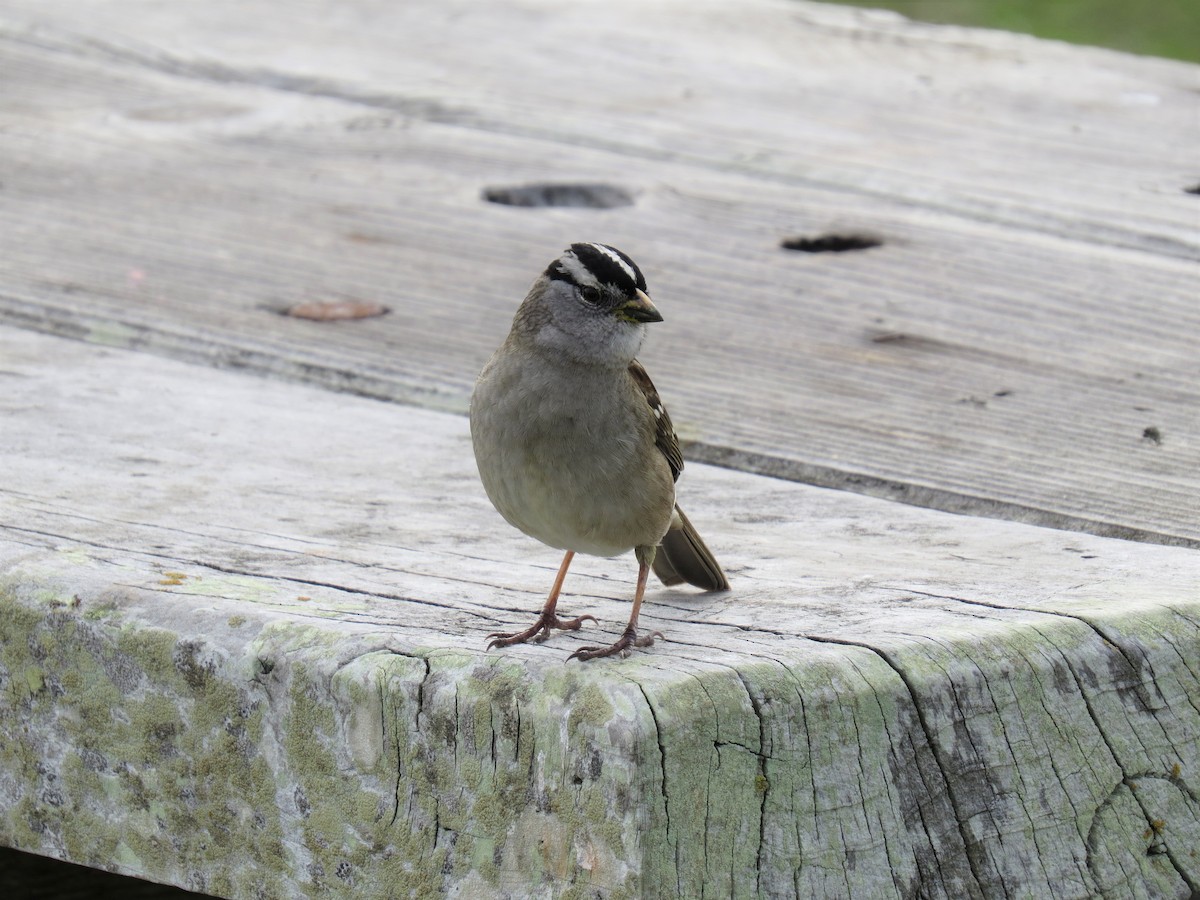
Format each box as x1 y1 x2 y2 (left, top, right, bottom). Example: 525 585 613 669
838 0 1200 62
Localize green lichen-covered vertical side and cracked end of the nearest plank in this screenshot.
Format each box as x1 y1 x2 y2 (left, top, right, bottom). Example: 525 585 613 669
0 573 1200 900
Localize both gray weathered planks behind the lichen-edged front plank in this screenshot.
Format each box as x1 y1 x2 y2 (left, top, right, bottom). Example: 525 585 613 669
0 0 1200 547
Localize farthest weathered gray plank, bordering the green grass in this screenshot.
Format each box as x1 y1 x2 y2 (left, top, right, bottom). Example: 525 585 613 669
6 0 1200 259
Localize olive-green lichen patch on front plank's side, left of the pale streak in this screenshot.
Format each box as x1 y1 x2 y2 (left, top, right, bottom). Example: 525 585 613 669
0 589 284 895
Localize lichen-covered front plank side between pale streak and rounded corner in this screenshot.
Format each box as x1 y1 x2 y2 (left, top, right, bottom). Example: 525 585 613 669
244 626 640 898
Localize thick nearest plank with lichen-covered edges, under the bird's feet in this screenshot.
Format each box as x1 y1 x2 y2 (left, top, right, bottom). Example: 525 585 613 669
0 329 1200 898
